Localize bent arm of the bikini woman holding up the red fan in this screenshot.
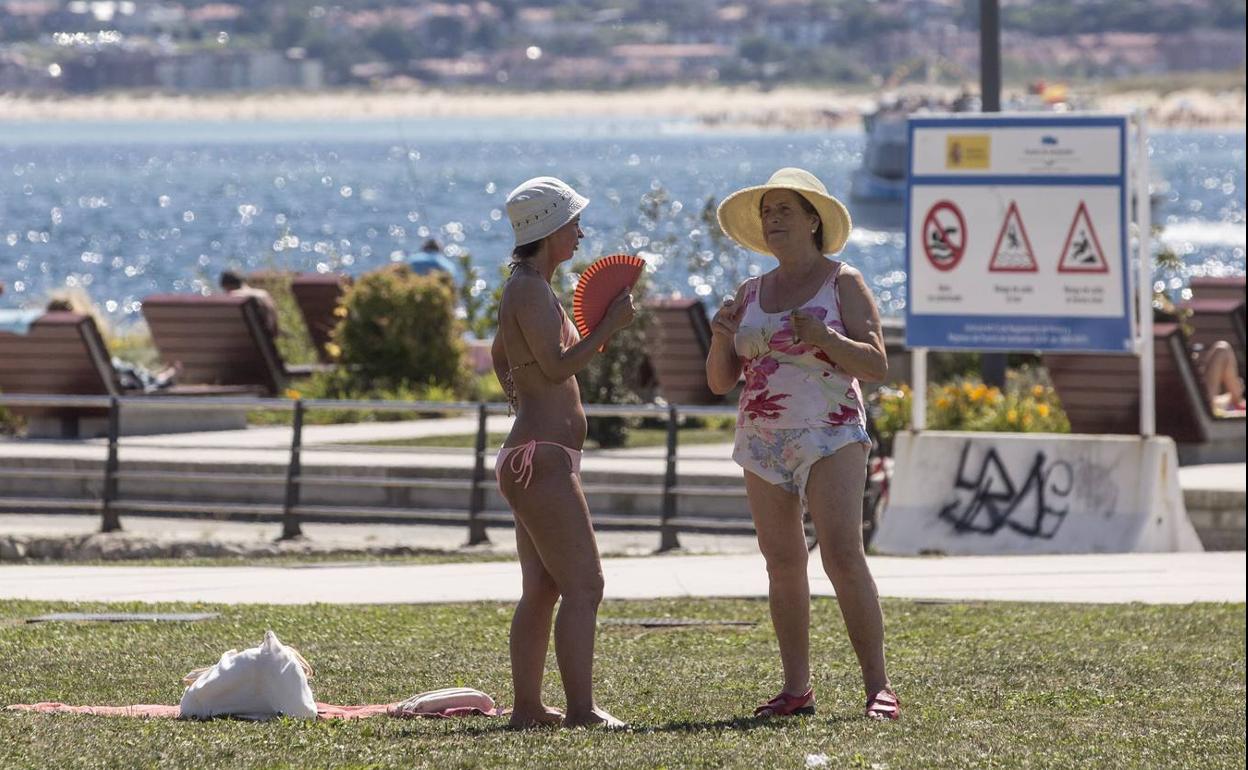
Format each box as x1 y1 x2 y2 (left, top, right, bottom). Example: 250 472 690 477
513 278 635 382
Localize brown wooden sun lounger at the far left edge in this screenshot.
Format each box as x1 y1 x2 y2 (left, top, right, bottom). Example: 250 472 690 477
0 312 260 438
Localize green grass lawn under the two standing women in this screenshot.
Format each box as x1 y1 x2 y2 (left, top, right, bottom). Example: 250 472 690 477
0 599 1244 770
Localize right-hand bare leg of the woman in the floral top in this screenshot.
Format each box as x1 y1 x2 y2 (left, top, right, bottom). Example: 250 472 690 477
806 444 889 698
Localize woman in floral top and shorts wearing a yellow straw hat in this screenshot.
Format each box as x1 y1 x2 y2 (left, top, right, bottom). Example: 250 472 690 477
706 168 901 719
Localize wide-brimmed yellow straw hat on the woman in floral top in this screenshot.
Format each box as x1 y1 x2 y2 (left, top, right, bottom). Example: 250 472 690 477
716 168 854 255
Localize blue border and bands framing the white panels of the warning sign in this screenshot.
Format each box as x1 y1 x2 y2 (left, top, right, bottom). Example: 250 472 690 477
905 114 1136 354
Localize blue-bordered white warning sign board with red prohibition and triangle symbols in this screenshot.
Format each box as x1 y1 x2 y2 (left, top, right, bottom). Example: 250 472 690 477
906 115 1133 353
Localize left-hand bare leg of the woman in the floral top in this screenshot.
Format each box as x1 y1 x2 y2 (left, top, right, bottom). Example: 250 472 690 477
745 470 810 695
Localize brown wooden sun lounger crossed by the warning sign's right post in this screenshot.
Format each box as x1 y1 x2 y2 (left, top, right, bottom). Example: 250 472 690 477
1043 323 1244 463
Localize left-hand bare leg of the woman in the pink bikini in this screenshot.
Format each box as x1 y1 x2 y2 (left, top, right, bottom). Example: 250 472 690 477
510 517 563 728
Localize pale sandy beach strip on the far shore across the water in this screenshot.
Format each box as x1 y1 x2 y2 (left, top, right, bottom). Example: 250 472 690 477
0 87 1246 131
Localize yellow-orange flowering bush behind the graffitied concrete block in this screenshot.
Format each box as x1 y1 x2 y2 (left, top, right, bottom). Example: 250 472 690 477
871 368 1071 453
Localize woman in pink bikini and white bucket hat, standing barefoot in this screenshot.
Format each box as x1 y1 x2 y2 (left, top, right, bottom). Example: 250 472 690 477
492 176 634 728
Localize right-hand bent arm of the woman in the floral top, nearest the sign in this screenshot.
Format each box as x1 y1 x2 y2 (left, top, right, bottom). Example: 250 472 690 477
794 266 889 382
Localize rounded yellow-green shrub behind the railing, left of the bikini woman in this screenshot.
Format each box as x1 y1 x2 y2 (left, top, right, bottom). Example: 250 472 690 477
333 263 467 397
